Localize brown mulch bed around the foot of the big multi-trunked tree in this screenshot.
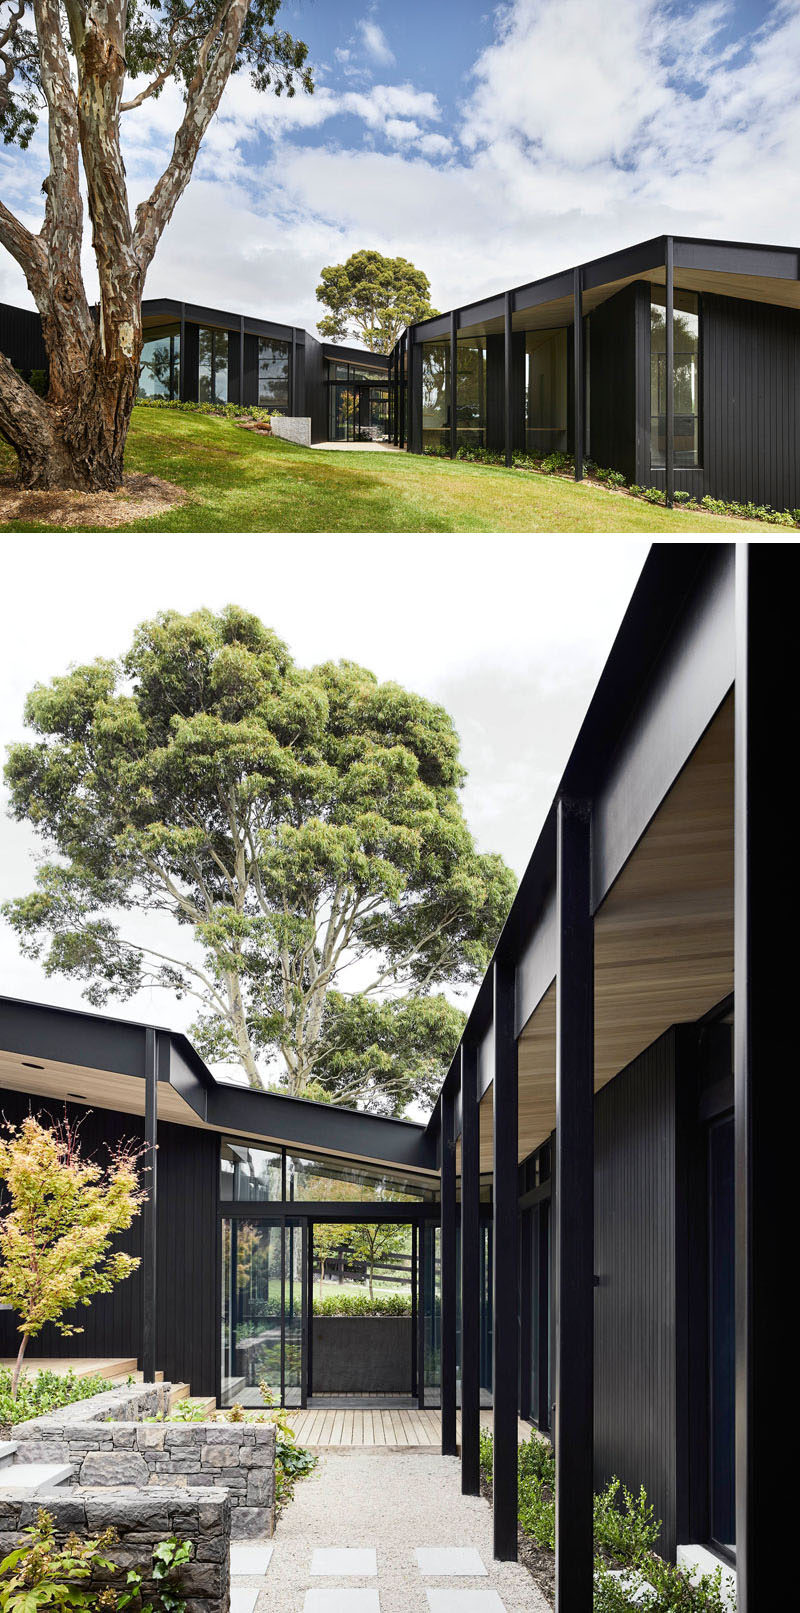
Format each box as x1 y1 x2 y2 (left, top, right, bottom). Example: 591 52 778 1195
0 474 189 531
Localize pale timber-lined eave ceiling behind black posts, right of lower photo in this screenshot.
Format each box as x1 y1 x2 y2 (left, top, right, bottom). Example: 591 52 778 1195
481 695 734 1171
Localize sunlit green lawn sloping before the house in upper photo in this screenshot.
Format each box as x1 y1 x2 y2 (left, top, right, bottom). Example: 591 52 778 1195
0 408 769 537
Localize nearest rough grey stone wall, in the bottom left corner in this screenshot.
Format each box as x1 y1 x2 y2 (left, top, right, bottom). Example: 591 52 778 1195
0 1487 231 1613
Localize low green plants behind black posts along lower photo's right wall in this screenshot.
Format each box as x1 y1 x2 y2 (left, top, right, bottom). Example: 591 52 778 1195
481 1429 729 1613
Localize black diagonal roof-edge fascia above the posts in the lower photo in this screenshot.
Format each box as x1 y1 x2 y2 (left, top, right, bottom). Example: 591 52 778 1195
427 544 731 1139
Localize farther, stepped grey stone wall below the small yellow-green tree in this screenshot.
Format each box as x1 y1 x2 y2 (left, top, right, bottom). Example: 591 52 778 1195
12 1384 276 1539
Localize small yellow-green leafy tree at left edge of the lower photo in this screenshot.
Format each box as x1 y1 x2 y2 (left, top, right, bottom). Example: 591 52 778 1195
0 1115 147 1395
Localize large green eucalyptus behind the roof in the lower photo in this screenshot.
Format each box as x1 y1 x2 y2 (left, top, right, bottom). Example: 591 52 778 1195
3 606 515 1113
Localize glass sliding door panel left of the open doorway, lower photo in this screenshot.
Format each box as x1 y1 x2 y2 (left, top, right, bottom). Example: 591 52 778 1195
221 1216 308 1407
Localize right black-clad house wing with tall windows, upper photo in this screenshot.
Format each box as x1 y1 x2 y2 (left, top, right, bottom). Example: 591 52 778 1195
390 235 800 510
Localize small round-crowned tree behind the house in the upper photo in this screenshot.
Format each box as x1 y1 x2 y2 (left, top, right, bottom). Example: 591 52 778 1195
316 252 439 353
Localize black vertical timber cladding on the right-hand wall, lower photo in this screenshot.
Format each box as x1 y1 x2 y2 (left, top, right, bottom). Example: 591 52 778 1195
595 1026 680 1558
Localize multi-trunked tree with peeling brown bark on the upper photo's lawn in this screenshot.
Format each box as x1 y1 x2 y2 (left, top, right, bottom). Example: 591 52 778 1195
0 0 313 489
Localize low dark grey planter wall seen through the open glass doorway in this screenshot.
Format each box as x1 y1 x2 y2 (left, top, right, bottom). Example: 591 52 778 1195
311 1316 411 1395
